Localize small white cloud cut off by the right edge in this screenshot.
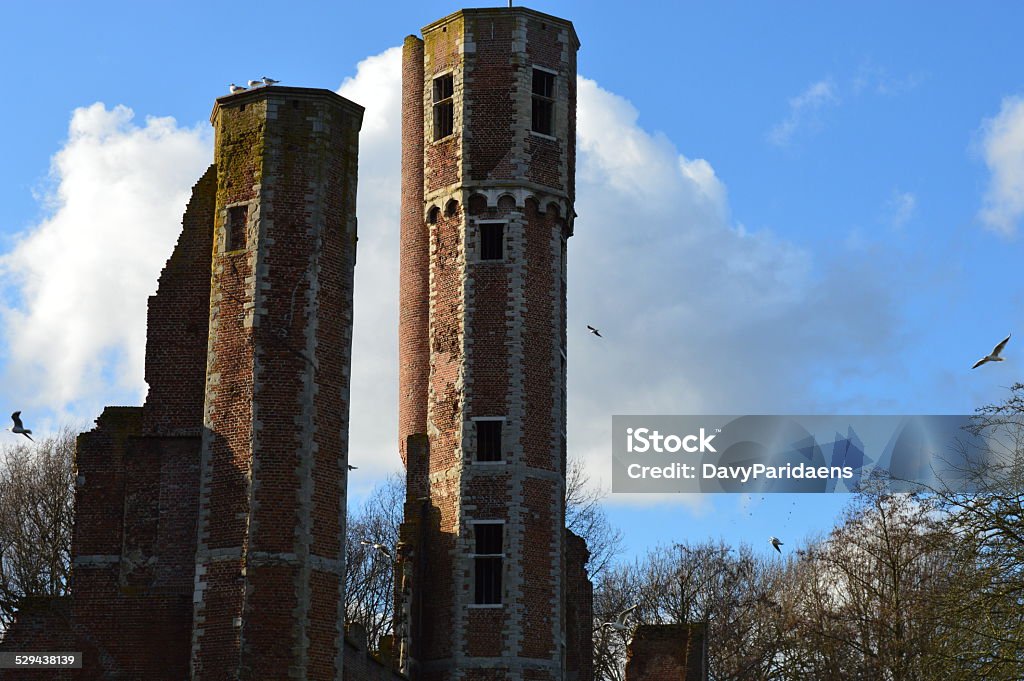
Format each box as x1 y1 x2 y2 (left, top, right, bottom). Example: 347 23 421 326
978 96 1024 237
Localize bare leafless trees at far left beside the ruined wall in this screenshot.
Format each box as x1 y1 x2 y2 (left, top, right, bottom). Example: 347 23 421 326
0 428 75 632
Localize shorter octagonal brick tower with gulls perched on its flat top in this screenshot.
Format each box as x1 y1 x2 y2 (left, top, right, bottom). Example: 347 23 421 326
191 87 362 679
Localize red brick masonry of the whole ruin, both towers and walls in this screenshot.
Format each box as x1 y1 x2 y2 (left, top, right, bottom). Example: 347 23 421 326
0 7 706 681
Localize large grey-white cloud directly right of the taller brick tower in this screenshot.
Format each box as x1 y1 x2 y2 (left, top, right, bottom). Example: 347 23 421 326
568 78 896 504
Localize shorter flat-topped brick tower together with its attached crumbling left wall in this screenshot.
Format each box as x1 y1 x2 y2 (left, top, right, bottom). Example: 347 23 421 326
0 87 374 680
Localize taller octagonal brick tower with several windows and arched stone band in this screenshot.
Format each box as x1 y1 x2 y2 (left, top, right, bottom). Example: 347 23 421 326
397 7 589 681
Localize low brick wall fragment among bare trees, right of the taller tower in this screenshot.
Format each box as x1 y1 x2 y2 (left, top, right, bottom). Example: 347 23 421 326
626 624 708 681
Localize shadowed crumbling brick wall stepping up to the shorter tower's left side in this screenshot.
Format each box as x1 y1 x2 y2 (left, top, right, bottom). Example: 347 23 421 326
5 168 222 679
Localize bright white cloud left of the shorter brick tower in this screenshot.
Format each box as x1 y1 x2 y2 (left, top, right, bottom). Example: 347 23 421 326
0 103 211 411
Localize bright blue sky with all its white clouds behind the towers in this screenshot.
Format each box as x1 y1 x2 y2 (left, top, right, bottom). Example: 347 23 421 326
0 0 1024 551
